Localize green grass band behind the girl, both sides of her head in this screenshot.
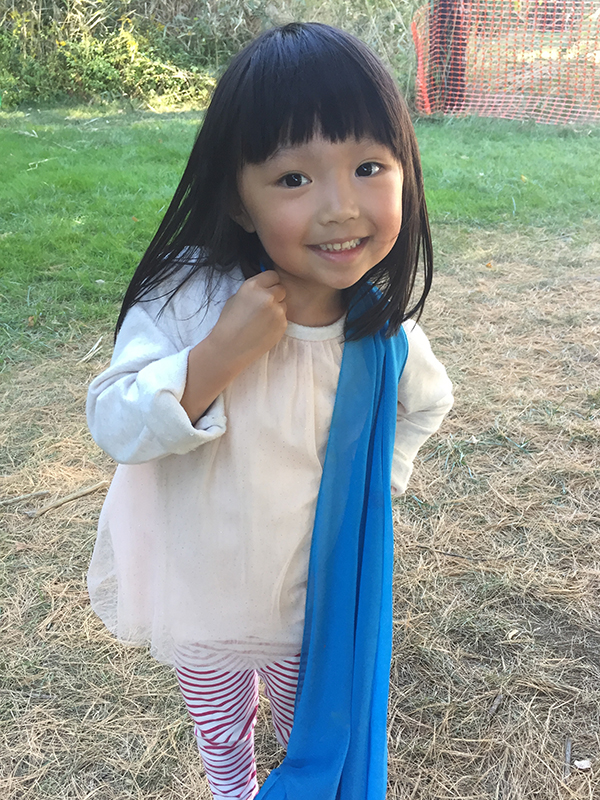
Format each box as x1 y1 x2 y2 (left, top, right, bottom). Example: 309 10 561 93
0 108 600 360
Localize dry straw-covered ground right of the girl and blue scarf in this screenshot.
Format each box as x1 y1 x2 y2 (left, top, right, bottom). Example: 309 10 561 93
390 231 600 800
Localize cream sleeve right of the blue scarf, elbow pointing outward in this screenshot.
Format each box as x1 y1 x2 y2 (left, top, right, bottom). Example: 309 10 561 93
392 321 454 495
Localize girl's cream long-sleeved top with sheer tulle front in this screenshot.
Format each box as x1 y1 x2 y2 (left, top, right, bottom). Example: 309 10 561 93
87 272 452 669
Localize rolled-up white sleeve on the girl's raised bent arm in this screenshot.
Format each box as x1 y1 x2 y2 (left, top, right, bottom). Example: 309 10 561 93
86 303 226 464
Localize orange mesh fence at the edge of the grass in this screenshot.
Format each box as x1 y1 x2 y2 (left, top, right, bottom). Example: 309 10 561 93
412 0 600 124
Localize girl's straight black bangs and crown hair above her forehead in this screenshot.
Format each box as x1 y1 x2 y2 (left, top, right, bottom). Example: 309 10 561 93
235 24 403 169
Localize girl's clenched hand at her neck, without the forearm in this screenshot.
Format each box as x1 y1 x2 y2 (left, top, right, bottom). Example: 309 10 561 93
208 270 287 369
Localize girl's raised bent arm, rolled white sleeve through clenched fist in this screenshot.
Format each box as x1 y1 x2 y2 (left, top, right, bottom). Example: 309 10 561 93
87 271 287 464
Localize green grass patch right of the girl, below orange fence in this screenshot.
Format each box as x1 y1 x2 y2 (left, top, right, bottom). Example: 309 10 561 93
417 114 600 232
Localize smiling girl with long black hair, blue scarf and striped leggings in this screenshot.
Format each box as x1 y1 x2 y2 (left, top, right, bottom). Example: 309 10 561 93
88 24 452 800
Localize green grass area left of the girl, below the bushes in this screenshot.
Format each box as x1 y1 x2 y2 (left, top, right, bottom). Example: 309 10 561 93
0 112 200 358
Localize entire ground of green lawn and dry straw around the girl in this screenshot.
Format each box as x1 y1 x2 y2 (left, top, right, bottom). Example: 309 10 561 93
0 109 600 800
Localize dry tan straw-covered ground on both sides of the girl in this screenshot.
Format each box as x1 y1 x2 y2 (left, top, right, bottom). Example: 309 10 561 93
0 227 600 800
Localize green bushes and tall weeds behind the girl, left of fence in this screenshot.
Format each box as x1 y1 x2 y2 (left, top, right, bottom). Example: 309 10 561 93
0 0 418 107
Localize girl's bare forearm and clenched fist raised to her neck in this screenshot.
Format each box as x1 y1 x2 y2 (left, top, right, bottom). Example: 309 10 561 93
180 270 287 423
